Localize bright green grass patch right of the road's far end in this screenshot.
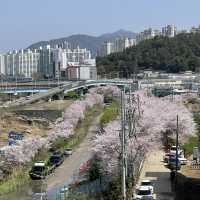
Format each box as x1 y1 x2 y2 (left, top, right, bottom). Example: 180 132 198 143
100 101 120 126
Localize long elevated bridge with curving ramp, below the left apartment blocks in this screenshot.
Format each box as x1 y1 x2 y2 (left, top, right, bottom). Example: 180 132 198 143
0 80 136 108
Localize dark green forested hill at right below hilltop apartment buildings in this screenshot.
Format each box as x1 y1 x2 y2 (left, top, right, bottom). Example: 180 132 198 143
97 33 200 76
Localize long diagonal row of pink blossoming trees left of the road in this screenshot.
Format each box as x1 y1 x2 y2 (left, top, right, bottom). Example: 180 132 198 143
1 86 119 164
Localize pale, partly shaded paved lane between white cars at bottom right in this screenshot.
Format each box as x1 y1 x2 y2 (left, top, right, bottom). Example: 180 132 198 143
139 151 174 200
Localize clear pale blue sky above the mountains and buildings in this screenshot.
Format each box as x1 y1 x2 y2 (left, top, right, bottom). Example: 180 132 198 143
0 0 200 52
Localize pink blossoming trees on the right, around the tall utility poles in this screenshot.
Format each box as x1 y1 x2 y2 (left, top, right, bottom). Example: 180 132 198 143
93 91 195 175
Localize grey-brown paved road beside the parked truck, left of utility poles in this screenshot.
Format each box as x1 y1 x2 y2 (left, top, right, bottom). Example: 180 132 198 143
46 116 100 198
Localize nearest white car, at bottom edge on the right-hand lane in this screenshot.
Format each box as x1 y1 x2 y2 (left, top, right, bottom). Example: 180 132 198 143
133 186 156 200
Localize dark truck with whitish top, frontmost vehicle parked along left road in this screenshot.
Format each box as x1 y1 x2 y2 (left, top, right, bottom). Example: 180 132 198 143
29 161 55 180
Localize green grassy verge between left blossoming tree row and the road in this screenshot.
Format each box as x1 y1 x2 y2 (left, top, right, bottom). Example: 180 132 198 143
0 105 103 195
